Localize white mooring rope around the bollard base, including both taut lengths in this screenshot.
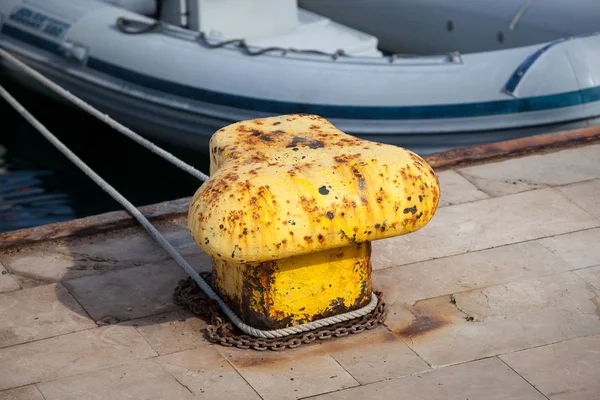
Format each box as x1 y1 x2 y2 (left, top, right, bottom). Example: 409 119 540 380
0 49 378 339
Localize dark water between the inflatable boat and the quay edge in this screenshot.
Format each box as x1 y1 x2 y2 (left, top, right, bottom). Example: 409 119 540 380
0 78 208 232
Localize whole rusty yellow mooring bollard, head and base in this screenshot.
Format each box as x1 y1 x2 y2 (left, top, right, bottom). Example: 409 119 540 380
188 115 440 329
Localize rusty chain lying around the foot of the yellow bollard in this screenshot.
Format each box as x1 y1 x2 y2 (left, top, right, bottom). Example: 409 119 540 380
173 272 386 351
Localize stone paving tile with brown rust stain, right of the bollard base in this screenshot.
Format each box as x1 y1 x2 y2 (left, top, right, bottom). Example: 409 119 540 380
386 272 600 366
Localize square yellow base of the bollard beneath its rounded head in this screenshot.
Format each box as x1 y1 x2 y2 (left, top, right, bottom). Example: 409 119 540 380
213 242 372 330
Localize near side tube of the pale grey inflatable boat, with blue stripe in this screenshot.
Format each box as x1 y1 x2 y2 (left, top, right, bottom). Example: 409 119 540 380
0 0 600 154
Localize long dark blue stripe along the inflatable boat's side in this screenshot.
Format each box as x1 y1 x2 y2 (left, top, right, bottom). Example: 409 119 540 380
2 24 600 120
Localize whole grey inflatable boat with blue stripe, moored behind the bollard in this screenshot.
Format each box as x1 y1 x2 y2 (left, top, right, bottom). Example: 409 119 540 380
0 0 600 154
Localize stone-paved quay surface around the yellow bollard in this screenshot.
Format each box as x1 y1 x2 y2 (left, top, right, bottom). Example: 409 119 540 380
0 143 600 400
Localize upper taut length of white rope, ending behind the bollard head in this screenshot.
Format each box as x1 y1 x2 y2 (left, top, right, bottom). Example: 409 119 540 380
0 48 209 181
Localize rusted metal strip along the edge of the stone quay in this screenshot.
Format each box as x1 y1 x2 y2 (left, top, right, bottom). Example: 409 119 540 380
0 126 600 248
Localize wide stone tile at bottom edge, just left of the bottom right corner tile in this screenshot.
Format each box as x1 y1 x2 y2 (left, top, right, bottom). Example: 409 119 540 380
314 358 545 400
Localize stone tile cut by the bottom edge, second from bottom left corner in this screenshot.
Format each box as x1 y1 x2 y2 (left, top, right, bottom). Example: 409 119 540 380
38 360 194 400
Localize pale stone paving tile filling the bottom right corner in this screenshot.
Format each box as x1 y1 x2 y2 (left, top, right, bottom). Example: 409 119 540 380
500 335 600 400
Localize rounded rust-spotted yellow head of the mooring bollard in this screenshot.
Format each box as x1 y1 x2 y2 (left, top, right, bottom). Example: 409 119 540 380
188 115 440 263
